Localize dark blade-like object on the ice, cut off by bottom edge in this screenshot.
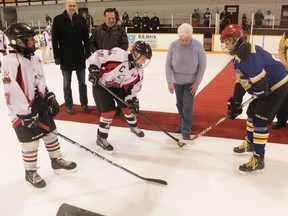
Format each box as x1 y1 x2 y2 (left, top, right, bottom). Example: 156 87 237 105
56 203 103 216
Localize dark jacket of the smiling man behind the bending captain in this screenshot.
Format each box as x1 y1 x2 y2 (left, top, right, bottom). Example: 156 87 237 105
89 23 128 53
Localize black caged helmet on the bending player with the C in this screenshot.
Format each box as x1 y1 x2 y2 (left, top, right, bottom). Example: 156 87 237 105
131 41 152 68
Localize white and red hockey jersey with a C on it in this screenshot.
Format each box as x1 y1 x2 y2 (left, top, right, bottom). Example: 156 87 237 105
86 47 144 101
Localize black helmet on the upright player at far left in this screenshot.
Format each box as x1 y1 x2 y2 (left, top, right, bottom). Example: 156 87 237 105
6 23 36 55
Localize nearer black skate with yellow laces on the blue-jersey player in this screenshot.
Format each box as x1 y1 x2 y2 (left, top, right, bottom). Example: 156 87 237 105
239 154 265 173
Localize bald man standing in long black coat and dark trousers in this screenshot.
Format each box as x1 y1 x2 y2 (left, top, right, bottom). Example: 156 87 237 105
52 0 91 115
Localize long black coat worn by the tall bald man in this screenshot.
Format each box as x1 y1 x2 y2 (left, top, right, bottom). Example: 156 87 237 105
52 11 91 71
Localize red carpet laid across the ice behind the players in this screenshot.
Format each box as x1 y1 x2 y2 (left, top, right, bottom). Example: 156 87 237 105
56 62 288 144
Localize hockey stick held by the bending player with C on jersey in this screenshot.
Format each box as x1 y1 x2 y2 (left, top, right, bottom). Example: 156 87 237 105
97 82 190 147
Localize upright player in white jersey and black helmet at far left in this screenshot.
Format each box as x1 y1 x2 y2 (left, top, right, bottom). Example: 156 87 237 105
2 23 76 189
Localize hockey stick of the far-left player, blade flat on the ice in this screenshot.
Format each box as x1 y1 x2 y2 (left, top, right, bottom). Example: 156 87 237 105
38 122 168 185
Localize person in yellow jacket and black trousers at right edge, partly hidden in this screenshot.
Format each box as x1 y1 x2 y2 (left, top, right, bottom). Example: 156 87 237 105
272 31 288 129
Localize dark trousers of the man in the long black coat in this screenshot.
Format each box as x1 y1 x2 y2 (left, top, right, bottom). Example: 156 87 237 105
62 70 88 108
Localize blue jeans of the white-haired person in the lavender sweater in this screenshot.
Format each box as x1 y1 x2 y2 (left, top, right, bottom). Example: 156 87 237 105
174 83 194 134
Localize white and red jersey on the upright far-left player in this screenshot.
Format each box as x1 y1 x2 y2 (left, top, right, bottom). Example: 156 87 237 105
1 53 47 123
